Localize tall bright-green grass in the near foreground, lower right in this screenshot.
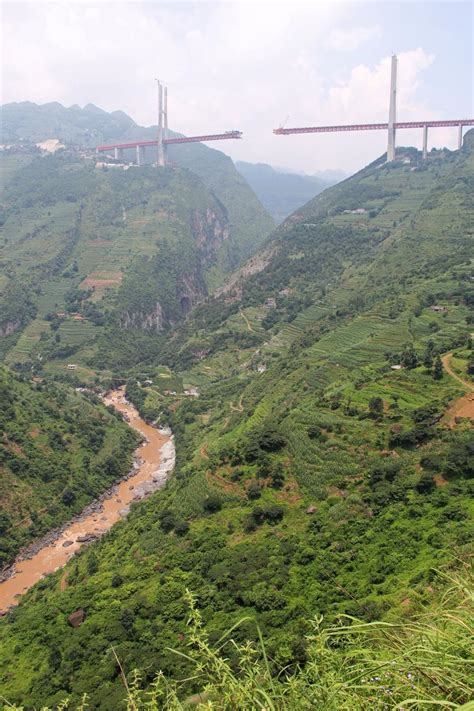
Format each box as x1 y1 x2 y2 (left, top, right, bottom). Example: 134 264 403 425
5 567 474 711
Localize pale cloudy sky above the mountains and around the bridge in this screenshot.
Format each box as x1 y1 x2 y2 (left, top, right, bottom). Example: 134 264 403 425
2 0 474 173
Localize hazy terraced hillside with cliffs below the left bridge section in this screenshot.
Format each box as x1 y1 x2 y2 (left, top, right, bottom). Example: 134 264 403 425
0 147 270 369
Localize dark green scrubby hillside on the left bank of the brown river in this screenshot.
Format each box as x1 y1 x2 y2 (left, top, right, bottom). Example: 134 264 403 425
0 370 137 570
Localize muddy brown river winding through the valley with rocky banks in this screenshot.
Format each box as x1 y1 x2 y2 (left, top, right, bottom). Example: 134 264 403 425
0 388 175 613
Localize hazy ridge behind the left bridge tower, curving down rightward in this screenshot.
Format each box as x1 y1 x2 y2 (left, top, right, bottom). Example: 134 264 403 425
1 102 274 266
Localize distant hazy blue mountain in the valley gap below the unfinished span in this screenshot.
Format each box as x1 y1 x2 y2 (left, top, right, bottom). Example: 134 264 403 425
235 161 337 223
